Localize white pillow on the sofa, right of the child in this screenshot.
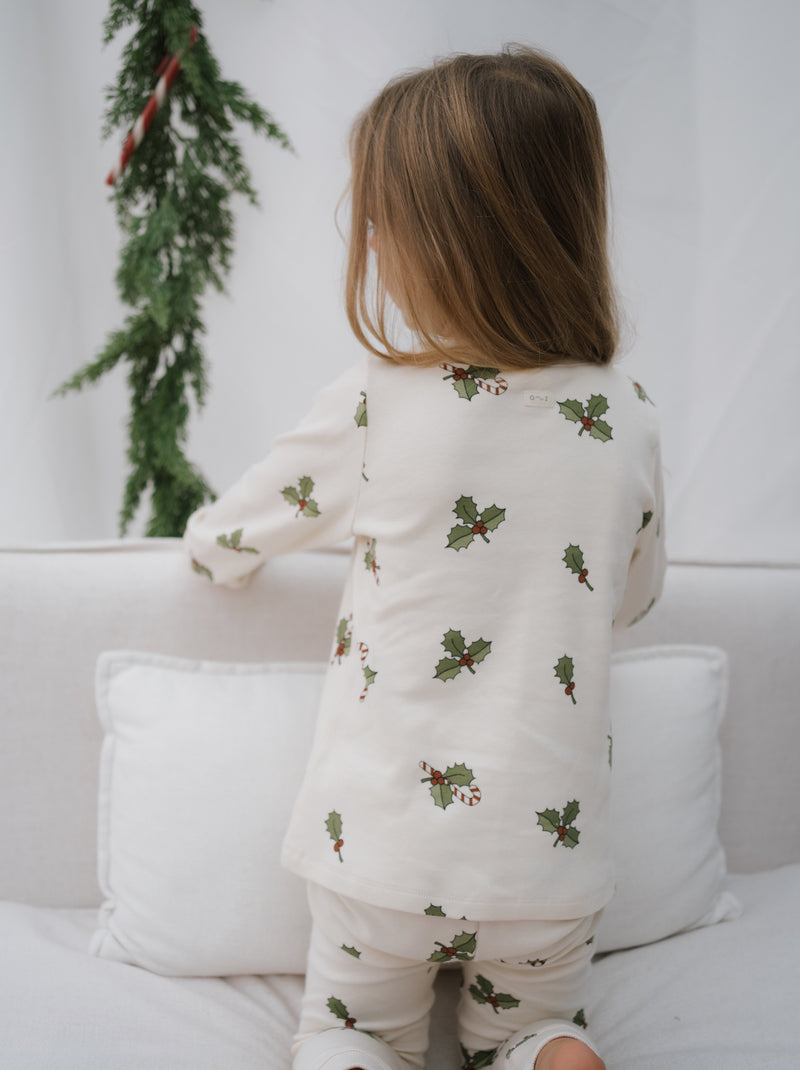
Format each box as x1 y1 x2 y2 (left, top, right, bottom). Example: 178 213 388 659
595 645 741 951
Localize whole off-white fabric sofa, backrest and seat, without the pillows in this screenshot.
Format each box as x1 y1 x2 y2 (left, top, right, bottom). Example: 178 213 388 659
0 540 800 1070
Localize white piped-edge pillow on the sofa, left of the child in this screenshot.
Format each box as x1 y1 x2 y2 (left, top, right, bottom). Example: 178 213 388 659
91 653 325 977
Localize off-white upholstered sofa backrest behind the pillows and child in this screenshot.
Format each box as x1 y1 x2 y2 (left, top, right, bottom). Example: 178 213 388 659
0 539 800 906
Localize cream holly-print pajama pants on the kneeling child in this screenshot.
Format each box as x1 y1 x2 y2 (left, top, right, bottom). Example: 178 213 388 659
292 884 599 1070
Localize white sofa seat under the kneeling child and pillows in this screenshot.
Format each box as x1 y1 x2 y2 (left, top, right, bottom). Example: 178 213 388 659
0 865 800 1070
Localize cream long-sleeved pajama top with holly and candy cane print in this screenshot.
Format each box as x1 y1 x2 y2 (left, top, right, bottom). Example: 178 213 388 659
185 356 665 920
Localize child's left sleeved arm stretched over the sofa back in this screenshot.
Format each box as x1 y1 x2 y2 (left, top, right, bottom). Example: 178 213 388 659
184 366 366 586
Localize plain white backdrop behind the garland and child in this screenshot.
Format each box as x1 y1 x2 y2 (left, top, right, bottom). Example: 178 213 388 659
0 0 800 563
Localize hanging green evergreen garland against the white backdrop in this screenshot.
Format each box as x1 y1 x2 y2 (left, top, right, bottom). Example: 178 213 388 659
56 0 291 536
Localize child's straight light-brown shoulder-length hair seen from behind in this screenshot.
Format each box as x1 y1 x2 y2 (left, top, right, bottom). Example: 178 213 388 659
345 46 618 368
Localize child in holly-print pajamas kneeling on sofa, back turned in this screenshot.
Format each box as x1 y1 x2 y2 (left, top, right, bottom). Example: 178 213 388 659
186 47 664 1070
